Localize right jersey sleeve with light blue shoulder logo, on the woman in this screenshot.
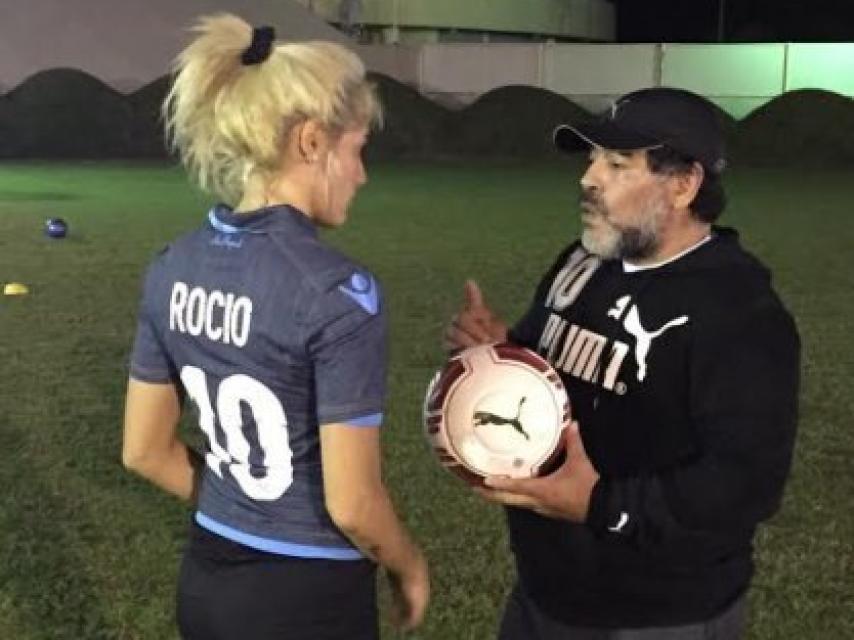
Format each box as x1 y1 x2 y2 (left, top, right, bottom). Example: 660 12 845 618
306 271 387 427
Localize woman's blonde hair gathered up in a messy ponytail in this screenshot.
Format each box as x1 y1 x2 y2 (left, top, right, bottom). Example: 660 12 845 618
163 14 381 204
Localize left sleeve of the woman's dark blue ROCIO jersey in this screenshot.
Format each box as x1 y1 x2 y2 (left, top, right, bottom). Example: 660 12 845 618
130 256 177 383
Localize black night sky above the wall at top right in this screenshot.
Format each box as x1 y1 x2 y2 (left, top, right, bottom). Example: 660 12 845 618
612 0 854 42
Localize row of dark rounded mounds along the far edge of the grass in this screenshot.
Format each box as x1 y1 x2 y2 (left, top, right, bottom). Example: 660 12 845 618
0 69 854 167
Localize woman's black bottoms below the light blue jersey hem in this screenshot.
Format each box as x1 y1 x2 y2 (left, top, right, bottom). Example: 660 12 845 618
177 524 379 640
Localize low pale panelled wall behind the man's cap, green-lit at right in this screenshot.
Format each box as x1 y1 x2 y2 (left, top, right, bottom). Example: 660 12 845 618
352 43 854 118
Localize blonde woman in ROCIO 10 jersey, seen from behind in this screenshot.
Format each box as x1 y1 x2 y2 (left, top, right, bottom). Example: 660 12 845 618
123 15 429 640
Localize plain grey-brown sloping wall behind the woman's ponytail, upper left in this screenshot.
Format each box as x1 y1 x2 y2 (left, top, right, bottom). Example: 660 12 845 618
0 0 349 92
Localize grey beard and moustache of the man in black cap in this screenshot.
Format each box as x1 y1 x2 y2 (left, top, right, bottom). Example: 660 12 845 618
581 192 667 260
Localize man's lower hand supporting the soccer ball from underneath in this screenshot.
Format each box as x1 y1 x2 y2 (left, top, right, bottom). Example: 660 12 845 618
477 422 599 523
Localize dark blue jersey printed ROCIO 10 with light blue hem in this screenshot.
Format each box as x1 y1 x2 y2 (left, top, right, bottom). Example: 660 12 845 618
130 205 386 559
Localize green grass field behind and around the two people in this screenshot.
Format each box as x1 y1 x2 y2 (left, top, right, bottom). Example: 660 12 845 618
0 156 854 640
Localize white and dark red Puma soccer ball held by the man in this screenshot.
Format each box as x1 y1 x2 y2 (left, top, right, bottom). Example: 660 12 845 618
424 343 571 484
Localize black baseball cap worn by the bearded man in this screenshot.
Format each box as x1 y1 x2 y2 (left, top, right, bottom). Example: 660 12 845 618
554 87 726 174
